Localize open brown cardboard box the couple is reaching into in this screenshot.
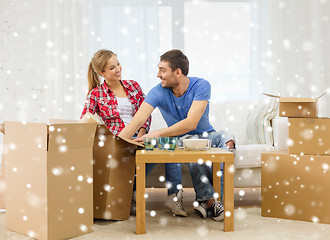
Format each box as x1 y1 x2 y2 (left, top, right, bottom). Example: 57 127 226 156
93 125 142 220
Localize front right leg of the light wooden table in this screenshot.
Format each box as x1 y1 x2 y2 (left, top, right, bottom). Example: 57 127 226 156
223 163 234 232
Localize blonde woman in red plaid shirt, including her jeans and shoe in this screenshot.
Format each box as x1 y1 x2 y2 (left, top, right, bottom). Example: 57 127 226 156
81 49 187 216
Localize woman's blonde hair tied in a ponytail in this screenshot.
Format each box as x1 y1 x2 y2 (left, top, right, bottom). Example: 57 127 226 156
87 49 117 93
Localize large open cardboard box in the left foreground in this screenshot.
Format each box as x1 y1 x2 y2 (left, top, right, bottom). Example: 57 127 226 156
5 122 96 239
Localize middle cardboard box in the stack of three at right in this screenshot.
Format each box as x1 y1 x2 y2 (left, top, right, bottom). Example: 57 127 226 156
289 118 330 155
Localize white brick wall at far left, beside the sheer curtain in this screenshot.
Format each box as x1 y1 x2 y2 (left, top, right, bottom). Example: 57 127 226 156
0 0 47 121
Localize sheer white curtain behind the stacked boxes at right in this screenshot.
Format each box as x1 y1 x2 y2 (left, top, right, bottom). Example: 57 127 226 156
250 0 330 117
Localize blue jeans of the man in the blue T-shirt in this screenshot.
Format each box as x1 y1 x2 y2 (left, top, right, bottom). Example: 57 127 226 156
189 131 235 201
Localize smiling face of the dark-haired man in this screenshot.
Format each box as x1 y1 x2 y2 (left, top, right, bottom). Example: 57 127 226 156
157 61 179 88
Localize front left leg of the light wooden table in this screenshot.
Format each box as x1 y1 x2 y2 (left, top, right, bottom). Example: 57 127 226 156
136 163 146 234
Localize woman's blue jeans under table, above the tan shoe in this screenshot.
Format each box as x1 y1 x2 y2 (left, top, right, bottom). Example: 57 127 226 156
133 162 182 195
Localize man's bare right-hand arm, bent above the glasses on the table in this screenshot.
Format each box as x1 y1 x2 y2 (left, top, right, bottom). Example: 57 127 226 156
137 101 208 140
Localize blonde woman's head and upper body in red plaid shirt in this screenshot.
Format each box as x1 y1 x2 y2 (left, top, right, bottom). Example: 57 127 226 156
81 49 151 137
